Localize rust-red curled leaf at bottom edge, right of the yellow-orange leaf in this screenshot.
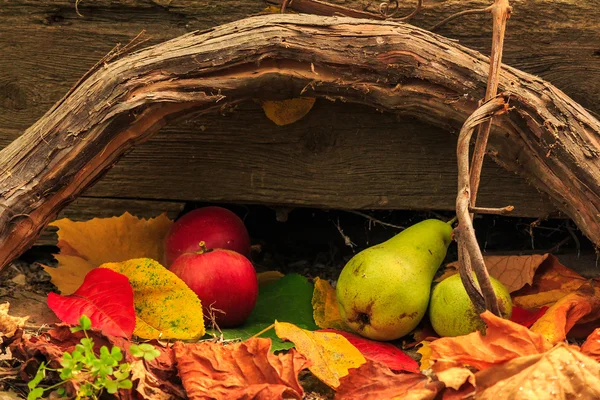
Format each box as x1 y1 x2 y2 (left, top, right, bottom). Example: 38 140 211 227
335 360 444 400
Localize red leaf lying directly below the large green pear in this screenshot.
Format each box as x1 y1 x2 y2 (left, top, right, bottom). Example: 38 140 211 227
319 329 419 372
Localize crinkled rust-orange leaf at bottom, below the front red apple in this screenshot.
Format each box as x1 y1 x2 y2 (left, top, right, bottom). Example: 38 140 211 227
173 338 310 400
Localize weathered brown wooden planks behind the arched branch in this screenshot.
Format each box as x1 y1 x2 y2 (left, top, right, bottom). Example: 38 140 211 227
0 0 600 222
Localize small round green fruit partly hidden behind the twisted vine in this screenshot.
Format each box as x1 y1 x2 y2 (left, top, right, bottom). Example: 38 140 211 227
429 274 512 336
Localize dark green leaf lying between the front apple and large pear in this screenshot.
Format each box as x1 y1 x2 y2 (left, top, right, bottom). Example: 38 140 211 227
213 274 319 351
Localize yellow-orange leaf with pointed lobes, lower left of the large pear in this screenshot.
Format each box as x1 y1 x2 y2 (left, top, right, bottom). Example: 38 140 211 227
275 321 366 389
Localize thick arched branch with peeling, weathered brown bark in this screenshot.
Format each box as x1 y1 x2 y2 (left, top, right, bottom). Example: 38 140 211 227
0 15 600 265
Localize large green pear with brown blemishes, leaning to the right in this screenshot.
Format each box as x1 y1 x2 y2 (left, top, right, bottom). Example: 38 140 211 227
336 219 452 340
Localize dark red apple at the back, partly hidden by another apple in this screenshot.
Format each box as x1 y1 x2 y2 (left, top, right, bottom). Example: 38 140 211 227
165 206 250 266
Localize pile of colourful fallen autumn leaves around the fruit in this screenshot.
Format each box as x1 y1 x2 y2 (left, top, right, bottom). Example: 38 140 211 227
9 214 600 400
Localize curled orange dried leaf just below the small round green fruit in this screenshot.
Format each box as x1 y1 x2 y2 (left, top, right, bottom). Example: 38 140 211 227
429 311 551 372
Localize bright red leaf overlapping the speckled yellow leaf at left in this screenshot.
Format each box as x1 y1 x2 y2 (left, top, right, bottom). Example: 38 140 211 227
48 268 135 338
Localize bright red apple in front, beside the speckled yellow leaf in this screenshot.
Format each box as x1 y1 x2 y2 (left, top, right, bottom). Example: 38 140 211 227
169 244 258 328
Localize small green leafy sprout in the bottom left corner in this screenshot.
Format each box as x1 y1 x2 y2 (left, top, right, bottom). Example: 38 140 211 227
27 315 160 400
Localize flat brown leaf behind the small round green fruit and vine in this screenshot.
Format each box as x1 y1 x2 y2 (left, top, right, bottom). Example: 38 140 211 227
436 254 549 293
